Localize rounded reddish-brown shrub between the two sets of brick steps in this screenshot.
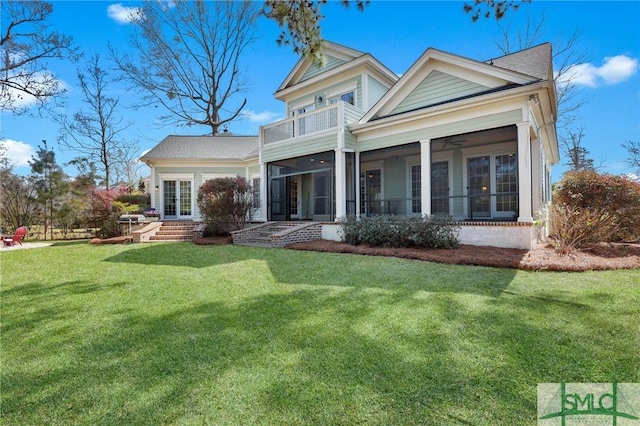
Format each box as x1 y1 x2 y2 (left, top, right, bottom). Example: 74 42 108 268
198 176 253 235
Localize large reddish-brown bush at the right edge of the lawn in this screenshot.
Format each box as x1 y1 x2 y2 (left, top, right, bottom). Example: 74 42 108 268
552 171 640 243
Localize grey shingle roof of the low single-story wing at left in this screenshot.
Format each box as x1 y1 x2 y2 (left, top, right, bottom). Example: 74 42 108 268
141 135 259 161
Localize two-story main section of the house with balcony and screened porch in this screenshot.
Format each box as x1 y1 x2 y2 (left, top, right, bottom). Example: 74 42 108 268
142 42 559 248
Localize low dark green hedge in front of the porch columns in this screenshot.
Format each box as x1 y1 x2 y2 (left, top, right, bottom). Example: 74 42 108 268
340 215 460 248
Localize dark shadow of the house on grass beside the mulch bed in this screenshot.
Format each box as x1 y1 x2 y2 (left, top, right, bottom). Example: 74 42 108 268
105 244 518 297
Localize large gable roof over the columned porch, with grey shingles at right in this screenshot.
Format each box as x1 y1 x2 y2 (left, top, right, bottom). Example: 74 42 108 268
360 43 551 123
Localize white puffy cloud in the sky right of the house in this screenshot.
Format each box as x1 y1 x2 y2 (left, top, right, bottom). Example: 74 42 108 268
560 55 638 87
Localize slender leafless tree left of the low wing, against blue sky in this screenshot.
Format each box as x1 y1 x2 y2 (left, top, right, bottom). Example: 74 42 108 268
56 55 137 189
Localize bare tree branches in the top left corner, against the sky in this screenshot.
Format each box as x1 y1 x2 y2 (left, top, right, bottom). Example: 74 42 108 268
0 0 75 113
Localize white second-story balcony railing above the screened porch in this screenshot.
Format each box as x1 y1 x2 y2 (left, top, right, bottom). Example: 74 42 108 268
260 101 364 146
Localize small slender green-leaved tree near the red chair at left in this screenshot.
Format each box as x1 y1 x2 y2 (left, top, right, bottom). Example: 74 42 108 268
29 140 67 240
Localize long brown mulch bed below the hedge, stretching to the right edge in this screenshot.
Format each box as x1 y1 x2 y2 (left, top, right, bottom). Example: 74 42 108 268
287 240 640 272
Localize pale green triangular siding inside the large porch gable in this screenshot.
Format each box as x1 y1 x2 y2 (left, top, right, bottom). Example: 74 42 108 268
391 70 489 115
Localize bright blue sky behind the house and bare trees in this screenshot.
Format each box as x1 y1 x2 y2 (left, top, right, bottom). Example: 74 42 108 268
0 0 640 181
